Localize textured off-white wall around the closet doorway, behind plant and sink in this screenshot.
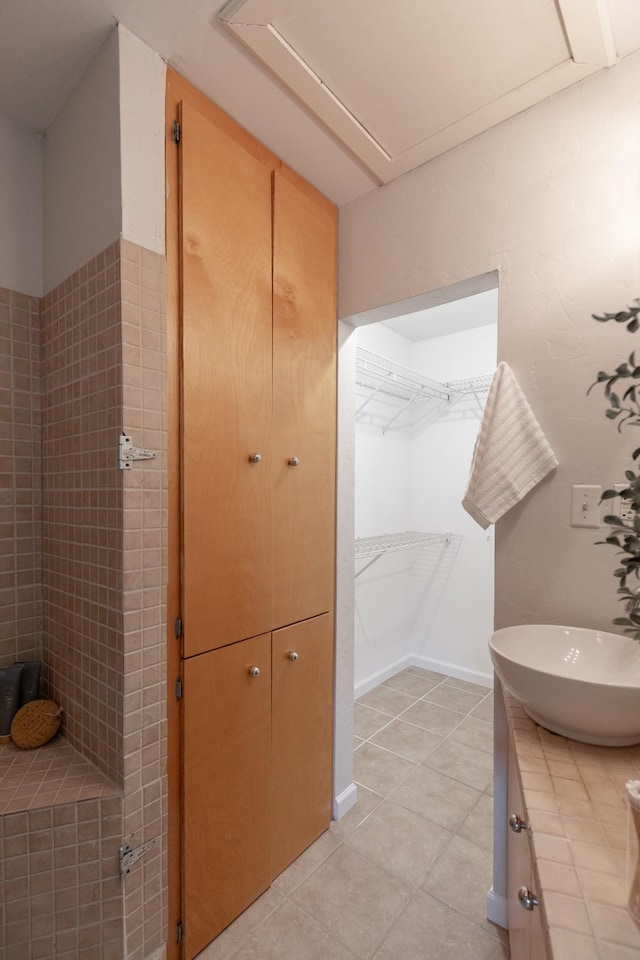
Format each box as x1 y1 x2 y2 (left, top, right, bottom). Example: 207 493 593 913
339 54 640 629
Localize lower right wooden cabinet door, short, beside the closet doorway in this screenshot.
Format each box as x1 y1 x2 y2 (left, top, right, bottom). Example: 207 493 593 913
271 614 333 877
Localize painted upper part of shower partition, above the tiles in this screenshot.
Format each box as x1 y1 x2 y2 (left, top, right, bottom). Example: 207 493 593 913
43 25 166 292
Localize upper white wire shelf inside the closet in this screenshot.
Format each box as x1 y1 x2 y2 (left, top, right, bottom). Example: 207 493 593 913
356 347 493 432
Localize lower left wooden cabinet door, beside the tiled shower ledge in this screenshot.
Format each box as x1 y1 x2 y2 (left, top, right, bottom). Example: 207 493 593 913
183 634 271 960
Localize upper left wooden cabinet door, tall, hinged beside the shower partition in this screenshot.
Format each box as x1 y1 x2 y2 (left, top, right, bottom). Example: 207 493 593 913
180 103 272 656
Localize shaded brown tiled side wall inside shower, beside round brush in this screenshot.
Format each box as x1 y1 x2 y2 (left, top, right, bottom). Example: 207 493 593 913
41 243 124 784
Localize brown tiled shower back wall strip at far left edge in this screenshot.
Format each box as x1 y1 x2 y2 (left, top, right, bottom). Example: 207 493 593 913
0 288 42 666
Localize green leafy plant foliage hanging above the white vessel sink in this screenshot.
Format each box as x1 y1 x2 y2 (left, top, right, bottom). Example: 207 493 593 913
587 300 640 640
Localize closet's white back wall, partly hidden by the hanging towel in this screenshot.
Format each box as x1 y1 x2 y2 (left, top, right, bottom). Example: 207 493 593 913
410 317 497 683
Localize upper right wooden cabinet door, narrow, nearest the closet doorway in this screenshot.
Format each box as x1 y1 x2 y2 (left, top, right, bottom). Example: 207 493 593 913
273 172 336 627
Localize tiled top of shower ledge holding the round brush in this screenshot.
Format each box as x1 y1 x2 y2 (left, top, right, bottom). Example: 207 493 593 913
0 737 120 816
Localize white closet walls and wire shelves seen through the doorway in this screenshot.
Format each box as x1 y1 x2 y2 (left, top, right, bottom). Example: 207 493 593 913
335 274 498 811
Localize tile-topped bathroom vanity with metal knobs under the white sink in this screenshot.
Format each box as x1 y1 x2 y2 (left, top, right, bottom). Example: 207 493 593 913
496 693 640 960
